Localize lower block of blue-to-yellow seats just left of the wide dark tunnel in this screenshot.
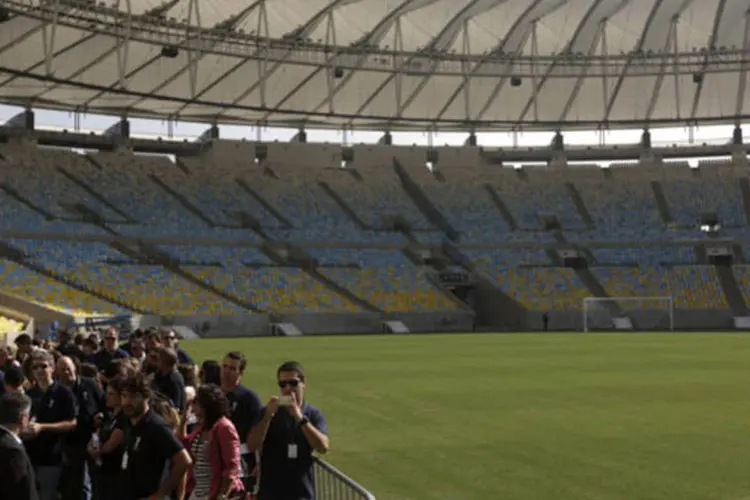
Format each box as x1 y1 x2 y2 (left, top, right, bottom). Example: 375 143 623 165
308 249 458 312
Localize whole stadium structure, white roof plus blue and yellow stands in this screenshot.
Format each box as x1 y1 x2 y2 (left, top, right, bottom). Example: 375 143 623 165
0 0 750 335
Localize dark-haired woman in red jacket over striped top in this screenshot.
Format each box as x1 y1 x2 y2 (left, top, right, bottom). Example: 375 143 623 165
183 384 245 500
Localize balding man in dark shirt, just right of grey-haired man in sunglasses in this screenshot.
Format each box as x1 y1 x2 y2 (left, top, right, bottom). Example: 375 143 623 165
57 356 104 500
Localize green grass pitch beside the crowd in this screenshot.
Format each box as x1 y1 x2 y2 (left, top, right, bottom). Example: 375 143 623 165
184 334 750 500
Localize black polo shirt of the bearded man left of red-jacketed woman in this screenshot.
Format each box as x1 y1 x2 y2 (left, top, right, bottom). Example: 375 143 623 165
122 409 183 500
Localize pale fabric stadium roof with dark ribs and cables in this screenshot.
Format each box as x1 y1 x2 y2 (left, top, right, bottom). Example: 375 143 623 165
0 0 750 130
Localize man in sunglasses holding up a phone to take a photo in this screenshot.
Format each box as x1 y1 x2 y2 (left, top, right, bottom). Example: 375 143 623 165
247 361 329 500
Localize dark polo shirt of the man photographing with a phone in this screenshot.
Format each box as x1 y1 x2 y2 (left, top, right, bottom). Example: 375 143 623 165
258 403 328 500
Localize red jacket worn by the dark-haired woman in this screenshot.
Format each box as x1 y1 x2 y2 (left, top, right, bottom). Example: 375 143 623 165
182 417 243 498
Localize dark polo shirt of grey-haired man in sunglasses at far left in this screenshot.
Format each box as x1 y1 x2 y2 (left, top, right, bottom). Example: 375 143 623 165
24 382 78 467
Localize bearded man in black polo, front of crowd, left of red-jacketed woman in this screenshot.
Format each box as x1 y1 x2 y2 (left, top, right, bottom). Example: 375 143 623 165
120 373 192 500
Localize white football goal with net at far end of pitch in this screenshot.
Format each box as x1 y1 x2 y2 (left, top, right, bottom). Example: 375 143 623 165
583 297 674 332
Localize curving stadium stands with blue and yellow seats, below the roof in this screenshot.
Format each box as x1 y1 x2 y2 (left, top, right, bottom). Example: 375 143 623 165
0 121 750 335
